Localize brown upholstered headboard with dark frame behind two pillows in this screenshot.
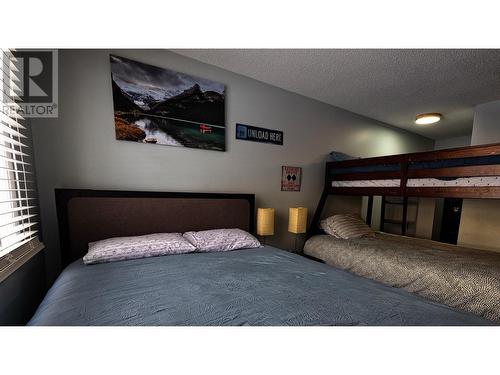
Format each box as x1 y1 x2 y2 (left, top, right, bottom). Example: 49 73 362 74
55 189 255 266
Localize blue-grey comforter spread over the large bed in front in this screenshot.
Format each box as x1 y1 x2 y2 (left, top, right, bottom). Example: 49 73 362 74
29 246 490 325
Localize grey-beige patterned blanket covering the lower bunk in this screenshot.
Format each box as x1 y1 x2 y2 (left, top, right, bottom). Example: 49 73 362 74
304 233 500 322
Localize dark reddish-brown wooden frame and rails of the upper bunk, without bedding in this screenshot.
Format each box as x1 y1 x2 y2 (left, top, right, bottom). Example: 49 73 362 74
308 143 500 238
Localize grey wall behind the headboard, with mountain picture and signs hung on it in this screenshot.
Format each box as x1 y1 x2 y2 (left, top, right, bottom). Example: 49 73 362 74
32 50 433 280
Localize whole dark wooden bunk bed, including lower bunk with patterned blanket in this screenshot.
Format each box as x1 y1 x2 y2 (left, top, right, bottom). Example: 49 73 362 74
304 144 500 323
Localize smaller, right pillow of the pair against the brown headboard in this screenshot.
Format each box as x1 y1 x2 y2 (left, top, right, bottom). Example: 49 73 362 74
184 229 260 252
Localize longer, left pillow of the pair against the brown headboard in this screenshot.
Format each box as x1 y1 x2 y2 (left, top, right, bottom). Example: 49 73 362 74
83 233 196 264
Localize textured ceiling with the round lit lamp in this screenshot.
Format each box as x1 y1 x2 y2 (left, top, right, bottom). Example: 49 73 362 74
174 49 500 139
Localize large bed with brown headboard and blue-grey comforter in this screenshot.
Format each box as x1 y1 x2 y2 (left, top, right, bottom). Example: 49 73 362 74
29 190 491 326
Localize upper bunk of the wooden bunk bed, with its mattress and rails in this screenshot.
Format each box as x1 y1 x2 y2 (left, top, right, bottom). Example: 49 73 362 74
308 143 500 237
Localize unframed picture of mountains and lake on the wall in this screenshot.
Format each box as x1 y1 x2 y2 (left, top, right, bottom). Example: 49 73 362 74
110 55 226 151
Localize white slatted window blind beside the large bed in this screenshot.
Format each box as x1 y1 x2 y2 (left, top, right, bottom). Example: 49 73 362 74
0 50 38 257
